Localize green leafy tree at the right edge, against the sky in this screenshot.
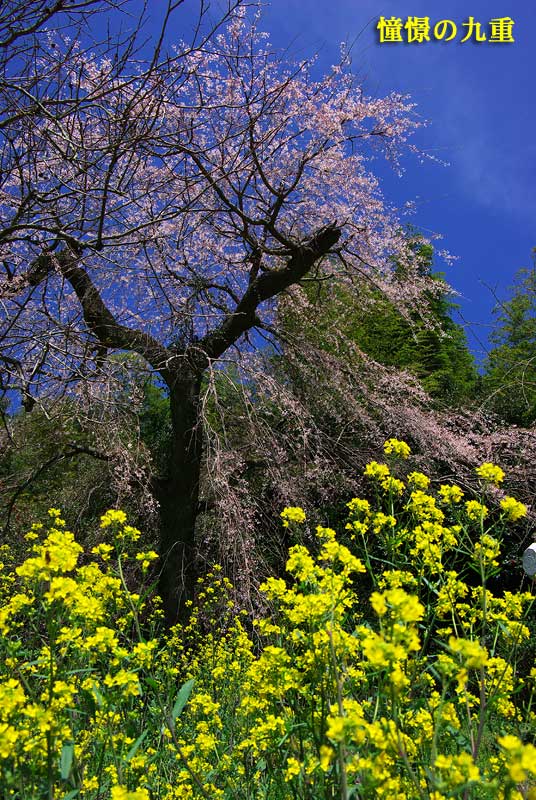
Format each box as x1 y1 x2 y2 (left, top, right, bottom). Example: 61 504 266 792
483 260 536 425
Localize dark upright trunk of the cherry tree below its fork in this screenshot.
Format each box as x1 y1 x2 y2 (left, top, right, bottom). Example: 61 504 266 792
157 375 202 627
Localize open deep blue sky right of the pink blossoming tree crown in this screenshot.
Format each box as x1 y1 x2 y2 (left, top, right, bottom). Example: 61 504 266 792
135 0 536 360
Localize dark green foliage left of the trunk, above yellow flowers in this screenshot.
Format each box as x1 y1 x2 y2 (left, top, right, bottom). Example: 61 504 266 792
0 354 163 556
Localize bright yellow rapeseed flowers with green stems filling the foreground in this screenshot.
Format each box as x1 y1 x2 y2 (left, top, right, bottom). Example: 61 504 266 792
0 439 536 800
